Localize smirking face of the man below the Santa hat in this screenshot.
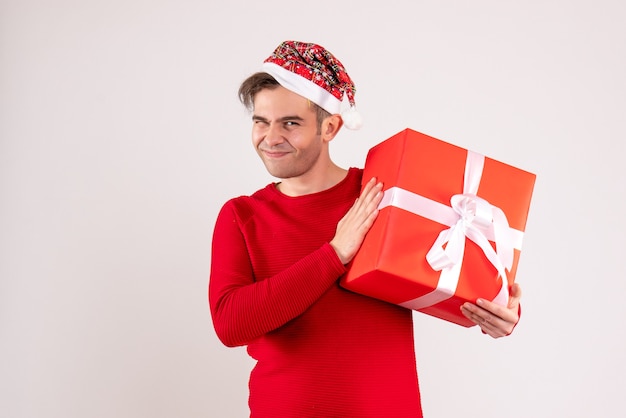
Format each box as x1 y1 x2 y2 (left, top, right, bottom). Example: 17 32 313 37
252 86 324 179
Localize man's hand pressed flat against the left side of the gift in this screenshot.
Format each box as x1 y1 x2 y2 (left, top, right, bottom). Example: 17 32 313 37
330 178 383 264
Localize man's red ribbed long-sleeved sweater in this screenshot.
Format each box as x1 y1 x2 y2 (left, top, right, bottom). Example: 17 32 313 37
209 168 422 418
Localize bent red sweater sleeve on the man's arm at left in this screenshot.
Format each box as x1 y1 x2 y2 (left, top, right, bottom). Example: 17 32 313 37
209 199 345 347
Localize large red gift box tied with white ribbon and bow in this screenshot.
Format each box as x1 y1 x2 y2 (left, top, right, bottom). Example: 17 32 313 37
341 129 536 327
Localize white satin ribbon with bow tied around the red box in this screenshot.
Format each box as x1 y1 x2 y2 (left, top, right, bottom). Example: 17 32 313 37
379 151 524 310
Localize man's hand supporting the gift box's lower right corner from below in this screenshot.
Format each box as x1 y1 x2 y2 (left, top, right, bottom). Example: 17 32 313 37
461 283 522 338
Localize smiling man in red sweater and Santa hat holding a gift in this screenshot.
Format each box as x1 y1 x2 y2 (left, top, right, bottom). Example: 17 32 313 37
209 41 521 418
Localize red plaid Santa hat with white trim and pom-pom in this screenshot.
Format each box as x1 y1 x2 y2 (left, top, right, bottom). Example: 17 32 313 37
262 41 362 129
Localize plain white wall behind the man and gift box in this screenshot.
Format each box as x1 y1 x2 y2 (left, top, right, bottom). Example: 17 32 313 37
0 0 626 418
